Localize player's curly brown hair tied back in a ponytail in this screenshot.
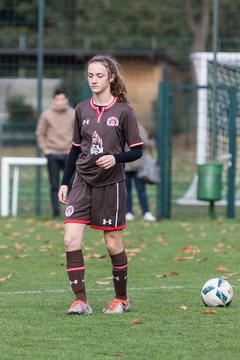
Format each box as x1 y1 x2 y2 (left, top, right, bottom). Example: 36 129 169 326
87 55 128 102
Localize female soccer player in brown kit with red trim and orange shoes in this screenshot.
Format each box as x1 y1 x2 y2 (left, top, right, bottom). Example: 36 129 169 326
58 55 143 314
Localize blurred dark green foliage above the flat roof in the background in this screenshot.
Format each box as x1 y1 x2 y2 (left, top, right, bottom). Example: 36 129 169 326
0 0 240 65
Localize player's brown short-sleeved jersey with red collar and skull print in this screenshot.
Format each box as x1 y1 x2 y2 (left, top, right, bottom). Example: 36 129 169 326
72 98 143 187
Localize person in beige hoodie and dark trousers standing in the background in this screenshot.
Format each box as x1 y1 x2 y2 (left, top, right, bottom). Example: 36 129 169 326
36 89 74 217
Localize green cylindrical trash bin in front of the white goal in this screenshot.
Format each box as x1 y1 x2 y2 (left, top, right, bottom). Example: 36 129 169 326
197 163 222 201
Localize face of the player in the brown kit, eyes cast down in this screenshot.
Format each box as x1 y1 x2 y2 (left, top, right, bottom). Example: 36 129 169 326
87 62 113 94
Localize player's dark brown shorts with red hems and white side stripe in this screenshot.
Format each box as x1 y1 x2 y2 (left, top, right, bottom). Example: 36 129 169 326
64 175 126 231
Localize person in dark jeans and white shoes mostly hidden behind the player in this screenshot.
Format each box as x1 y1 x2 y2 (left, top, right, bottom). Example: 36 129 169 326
125 125 156 221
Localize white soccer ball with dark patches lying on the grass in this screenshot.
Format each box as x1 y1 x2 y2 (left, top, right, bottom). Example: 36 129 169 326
201 278 233 307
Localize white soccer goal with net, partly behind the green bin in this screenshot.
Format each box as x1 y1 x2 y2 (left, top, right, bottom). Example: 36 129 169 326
177 52 240 205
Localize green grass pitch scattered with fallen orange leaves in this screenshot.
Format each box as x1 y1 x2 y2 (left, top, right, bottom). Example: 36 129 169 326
0 218 240 360
